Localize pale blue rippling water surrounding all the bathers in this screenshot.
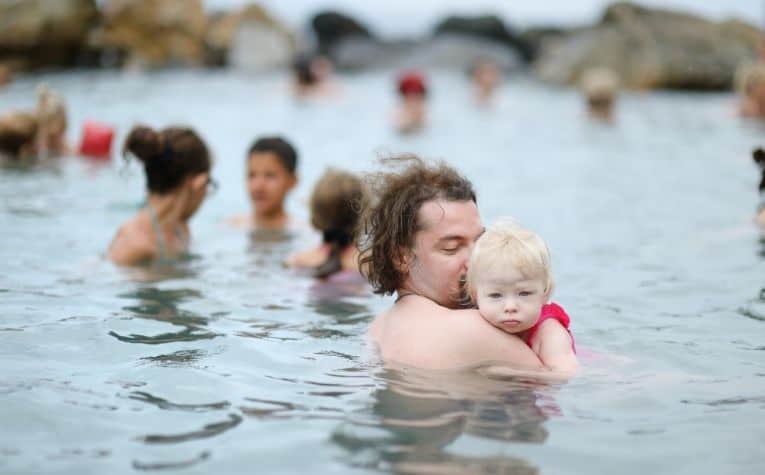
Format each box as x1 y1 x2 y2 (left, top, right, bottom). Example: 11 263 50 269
0 72 765 474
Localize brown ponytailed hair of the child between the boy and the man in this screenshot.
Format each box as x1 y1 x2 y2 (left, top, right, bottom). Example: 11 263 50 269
311 168 369 278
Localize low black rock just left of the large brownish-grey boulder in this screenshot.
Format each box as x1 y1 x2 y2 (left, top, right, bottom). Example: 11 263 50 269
434 15 532 60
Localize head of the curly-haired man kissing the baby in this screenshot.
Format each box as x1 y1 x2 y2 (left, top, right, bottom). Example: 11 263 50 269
359 156 483 308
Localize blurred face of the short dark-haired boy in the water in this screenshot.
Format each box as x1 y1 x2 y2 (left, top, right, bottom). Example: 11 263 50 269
247 152 297 216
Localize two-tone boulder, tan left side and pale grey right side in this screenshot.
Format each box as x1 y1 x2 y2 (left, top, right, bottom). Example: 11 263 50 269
205 4 295 72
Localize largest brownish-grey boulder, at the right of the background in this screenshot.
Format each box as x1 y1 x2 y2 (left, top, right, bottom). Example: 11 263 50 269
535 3 761 90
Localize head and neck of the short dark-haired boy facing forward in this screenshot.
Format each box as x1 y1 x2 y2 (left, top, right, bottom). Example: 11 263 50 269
247 137 298 230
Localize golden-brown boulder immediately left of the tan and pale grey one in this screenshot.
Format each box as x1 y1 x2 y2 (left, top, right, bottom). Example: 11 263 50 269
90 0 207 67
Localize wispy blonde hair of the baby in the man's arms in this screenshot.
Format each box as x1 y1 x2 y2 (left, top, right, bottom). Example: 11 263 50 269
465 218 554 303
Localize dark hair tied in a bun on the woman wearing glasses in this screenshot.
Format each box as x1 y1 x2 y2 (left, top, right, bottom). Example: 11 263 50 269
122 125 211 194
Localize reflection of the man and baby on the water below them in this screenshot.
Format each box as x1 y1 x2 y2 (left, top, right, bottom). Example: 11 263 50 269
332 368 555 474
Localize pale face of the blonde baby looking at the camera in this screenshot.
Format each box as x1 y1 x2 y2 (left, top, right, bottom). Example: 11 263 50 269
475 268 549 333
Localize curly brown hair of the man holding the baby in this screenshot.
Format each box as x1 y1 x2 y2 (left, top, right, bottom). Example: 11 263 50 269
359 155 476 295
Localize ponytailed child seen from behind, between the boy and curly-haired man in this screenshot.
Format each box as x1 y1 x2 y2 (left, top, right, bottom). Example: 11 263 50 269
286 169 368 278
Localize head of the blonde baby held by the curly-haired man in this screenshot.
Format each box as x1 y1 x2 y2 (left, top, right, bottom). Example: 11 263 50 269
465 219 554 333
